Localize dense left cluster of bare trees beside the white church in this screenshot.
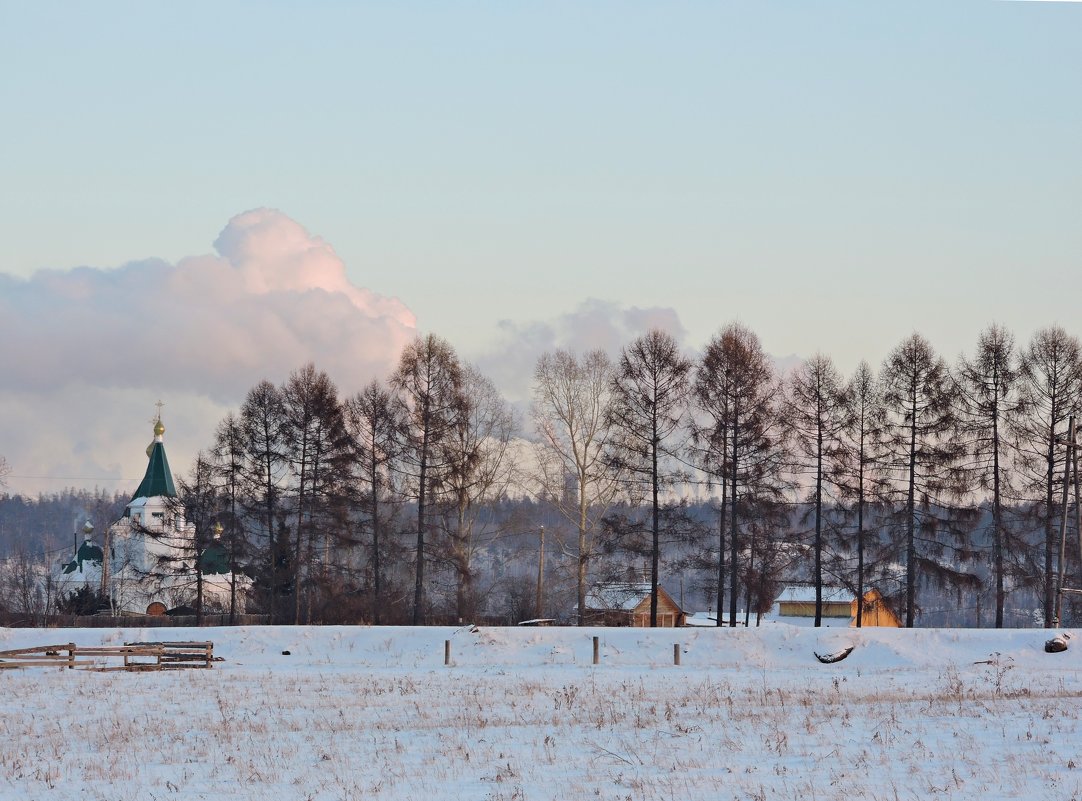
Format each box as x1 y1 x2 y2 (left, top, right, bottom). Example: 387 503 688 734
162 336 514 623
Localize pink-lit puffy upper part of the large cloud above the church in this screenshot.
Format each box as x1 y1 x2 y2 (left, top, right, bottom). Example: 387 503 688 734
0 209 415 398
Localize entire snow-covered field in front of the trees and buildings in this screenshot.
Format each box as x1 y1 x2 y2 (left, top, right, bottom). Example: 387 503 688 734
0 623 1082 801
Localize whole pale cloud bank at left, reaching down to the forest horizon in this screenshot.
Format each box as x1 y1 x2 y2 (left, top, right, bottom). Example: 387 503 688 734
0 209 415 491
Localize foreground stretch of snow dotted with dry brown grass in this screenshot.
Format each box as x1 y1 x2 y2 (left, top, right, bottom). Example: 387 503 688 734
0 645 1082 801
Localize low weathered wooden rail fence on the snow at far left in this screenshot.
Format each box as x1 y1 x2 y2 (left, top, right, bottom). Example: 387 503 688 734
0 642 214 672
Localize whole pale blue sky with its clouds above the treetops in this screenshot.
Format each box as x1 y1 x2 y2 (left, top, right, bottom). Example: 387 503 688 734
0 0 1082 493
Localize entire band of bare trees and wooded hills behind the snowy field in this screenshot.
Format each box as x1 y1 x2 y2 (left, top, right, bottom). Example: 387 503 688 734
0 324 1082 627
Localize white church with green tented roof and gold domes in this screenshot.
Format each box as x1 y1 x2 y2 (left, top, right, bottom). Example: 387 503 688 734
57 412 250 615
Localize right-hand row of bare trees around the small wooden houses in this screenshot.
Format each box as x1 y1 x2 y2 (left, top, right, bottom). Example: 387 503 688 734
525 324 1082 626
